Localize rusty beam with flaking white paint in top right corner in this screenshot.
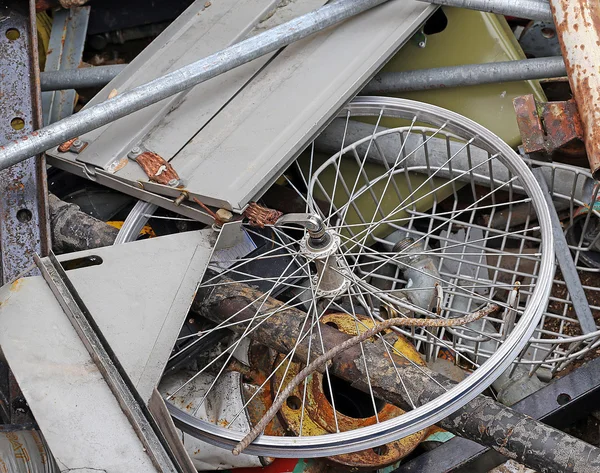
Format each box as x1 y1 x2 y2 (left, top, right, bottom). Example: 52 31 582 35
550 0 600 179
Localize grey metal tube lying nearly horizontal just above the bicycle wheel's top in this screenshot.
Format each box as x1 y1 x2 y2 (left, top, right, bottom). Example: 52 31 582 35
361 56 567 95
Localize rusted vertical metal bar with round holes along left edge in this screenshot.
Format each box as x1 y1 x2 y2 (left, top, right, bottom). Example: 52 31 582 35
0 1 49 282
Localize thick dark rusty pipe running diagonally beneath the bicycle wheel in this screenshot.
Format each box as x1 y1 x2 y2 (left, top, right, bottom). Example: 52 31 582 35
193 282 600 473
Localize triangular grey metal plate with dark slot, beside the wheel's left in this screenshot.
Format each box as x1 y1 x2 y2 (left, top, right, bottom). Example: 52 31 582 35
59 229 215 400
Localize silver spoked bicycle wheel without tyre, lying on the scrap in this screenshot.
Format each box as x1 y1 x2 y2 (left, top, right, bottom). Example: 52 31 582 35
163 97 554 458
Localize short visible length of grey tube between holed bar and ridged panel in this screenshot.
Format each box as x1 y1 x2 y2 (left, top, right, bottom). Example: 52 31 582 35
40 64 127 91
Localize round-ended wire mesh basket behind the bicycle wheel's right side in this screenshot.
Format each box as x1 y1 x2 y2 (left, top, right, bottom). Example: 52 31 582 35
312 121 600 377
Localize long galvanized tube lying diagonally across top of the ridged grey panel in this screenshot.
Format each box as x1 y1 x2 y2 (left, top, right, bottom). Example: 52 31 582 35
0 0 387 169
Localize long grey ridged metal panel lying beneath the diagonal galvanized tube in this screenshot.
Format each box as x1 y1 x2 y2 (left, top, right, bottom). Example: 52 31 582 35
49 0 436 219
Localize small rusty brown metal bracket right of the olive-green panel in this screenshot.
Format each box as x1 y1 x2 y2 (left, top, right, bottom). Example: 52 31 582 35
513 95 583 153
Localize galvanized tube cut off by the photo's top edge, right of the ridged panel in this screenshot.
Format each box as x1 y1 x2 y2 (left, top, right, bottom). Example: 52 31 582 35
422 0 552 21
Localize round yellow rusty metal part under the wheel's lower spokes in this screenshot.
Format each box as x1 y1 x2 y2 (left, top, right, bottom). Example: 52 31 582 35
271 313 428 468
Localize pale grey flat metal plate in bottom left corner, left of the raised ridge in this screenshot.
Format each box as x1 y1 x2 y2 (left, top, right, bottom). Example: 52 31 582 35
0 277 157 473
